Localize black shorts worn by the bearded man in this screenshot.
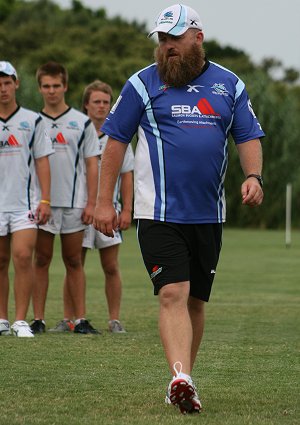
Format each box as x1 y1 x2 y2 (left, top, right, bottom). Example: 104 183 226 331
137 219 223 301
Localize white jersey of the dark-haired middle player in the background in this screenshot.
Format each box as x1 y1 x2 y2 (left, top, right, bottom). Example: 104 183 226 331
41 108 100 208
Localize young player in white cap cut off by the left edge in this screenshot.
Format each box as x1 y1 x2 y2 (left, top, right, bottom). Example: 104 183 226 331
0 61 53 337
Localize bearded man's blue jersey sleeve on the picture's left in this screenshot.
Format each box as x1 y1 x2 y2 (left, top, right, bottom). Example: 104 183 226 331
101 80 145 143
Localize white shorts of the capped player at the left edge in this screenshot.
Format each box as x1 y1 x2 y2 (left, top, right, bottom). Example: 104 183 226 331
0 210 38 236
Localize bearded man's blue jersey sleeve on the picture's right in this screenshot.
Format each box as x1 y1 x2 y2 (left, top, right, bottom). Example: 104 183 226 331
230 87 265 144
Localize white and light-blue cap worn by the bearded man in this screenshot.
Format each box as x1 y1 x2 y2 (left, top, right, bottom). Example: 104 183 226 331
148 4 202 37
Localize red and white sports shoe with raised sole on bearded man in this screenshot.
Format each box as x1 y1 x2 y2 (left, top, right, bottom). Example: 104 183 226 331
165 362 202 414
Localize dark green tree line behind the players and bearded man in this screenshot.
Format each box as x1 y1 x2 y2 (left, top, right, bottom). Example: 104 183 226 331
0 0 300 228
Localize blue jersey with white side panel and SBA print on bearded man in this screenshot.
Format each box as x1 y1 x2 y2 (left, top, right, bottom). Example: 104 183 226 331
102 62 264 223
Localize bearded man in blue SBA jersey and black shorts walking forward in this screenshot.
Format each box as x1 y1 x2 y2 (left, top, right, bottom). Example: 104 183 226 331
94 4 264 413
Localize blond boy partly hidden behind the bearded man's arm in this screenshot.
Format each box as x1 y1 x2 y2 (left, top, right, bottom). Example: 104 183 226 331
50 80 134 333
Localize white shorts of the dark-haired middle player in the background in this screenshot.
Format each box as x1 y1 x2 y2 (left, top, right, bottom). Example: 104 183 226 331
39 207 86 235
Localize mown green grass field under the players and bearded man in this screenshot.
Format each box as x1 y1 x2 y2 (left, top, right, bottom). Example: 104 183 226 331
0 229 300 425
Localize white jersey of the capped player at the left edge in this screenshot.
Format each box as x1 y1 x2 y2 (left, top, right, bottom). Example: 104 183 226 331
0 107 54 212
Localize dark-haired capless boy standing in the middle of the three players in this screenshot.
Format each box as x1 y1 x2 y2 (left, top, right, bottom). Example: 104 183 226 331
31 62 100 334
